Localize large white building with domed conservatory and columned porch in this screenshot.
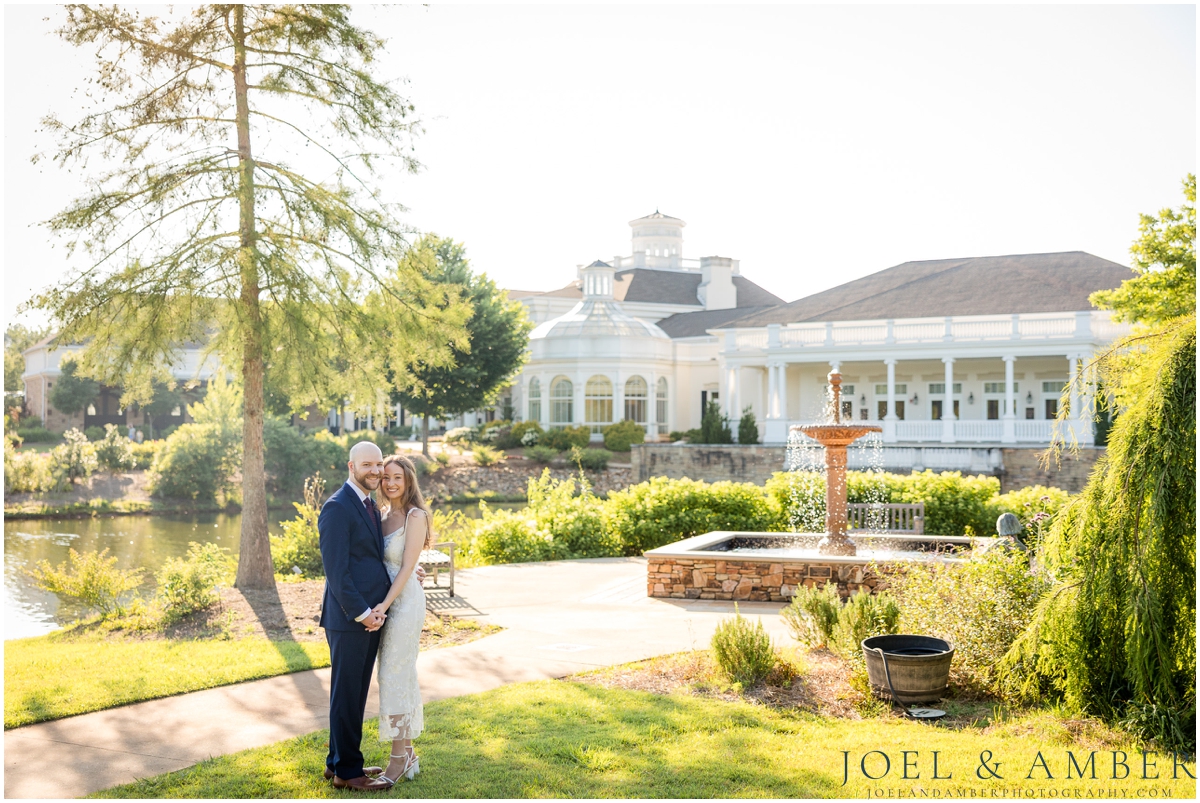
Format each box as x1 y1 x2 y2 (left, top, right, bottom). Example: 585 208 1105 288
510 212 1133 469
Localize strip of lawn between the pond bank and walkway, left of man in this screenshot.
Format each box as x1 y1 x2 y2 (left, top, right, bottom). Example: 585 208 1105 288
4 634 329 730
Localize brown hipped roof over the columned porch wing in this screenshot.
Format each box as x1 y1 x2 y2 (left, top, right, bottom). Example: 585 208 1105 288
720 251 1134 326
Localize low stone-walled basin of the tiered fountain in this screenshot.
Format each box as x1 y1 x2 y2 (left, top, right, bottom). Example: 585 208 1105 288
646 532 996 603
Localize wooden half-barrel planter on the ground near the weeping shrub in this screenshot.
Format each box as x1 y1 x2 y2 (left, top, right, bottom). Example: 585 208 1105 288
863 635 954 706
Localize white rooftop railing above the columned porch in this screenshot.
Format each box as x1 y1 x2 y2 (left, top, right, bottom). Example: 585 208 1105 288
726 312 1129 350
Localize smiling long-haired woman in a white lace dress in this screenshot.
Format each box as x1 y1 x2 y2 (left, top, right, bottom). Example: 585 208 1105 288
374 455 431 784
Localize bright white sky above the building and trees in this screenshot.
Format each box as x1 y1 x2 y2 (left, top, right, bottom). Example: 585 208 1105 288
4 5 1196 320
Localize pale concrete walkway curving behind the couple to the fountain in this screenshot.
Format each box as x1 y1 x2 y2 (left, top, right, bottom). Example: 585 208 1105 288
11 558 787 798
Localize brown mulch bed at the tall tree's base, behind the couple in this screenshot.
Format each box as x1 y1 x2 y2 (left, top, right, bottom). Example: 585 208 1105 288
105 580 500 649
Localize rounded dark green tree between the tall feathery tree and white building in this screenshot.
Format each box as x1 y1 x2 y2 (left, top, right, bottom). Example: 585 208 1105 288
394 234 533 456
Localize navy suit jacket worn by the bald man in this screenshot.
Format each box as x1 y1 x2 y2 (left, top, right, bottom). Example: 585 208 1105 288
317 484 391 630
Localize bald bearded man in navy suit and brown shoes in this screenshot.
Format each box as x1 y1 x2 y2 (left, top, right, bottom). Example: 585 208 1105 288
317 441 408 792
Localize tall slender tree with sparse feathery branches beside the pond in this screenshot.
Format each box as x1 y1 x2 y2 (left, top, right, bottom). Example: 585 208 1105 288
24 5 456 588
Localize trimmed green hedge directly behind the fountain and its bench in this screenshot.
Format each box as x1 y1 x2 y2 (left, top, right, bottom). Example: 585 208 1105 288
767 471 1000 535
